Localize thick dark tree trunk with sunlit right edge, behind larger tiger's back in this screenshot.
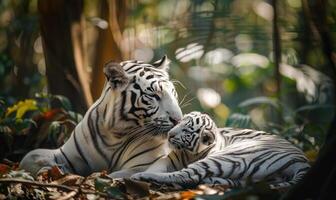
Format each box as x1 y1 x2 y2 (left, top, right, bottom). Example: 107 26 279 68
38 0 92 113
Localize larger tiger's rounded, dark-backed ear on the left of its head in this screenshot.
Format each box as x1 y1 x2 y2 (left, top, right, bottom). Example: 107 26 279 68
104 61 129 90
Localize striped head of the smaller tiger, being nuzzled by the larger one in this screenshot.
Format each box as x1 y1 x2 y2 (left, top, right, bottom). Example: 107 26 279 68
168 112 217 153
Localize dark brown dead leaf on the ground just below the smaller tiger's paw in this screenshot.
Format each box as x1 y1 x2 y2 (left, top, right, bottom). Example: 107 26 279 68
124 179 149 197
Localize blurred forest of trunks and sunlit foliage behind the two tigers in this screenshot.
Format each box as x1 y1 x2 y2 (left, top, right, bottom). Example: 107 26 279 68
0 0 336 161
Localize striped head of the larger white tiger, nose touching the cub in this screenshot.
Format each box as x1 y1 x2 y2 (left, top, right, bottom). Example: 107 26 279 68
101 56 182 134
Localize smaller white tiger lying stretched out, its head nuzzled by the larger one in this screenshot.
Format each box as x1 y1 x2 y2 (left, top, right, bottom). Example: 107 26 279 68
131 112 310 188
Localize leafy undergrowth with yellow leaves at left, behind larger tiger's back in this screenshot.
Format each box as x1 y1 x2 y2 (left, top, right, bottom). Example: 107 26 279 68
0 94 82 160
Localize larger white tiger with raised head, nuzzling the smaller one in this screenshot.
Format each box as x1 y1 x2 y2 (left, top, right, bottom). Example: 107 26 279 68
20 56 182 178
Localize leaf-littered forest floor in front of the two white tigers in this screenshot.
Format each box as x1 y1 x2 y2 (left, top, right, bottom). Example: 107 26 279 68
0 162 282 200
